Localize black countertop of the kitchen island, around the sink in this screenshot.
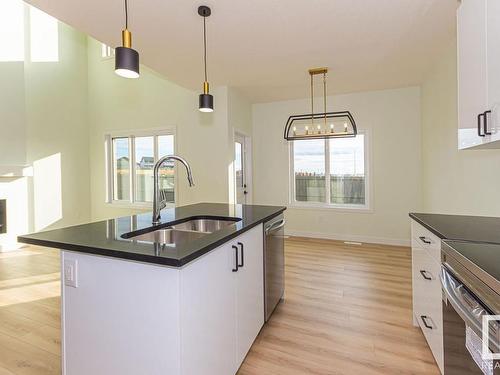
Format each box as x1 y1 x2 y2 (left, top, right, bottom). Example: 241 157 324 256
18 203 286 267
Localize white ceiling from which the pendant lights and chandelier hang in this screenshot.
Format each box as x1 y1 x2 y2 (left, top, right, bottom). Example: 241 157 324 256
27 0 458 102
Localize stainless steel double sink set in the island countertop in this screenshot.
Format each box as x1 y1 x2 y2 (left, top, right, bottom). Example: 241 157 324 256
122 218 240 245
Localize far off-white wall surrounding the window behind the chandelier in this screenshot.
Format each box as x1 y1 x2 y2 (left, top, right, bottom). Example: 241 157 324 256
253 87 421 244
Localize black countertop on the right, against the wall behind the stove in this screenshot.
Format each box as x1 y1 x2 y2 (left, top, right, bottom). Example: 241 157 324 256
410 213 500 244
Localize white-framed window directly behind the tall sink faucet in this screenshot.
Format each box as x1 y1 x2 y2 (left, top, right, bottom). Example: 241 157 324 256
106 131 175 205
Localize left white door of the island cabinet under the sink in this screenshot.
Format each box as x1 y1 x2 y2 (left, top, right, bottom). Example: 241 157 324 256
180 244 237 375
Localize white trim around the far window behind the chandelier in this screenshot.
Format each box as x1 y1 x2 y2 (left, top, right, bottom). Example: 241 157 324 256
288 129 373 213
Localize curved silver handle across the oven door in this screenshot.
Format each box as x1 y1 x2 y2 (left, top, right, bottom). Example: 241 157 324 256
441 268 488 336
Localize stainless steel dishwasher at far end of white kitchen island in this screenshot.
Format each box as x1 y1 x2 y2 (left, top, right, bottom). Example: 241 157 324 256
264 214 285 322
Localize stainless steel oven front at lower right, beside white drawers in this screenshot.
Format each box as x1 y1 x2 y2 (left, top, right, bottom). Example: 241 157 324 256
441 244 500 375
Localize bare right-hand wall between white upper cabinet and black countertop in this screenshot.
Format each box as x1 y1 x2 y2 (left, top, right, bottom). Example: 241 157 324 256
422 41 500 216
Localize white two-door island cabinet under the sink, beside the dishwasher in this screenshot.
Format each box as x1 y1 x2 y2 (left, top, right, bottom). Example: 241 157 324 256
180 225 264 375
